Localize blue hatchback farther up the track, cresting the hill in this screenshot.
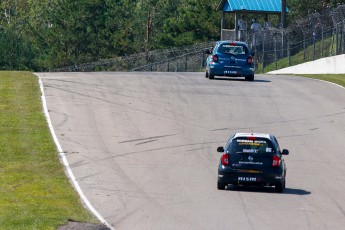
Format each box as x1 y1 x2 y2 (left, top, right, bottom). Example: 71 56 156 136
205 41 254 81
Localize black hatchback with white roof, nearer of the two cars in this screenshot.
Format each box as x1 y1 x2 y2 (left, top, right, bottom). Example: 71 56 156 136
217 133 289 193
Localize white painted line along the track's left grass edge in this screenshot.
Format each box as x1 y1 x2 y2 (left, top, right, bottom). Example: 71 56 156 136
38 77 115 230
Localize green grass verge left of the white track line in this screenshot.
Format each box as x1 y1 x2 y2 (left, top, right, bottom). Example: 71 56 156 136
0 72 98 229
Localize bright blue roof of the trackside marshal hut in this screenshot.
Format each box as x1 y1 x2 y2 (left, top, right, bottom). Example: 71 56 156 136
217 0 288 14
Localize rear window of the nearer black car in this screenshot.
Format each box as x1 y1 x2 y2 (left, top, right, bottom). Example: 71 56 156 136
227 138 274 155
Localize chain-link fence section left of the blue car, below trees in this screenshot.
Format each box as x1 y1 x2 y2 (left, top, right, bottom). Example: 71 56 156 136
50 42 214 72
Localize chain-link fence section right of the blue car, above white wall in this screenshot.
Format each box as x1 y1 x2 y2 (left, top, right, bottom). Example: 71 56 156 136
247 5 345 72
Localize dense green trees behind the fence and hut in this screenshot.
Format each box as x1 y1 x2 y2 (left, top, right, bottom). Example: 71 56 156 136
0 0 345 71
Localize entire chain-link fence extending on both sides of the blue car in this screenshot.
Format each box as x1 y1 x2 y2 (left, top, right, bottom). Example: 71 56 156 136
51 5 345 73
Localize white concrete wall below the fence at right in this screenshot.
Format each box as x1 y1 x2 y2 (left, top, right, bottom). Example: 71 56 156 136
268 54 345 74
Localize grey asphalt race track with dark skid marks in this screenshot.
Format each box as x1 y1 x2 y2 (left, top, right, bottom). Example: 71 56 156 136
37 72 345 230
